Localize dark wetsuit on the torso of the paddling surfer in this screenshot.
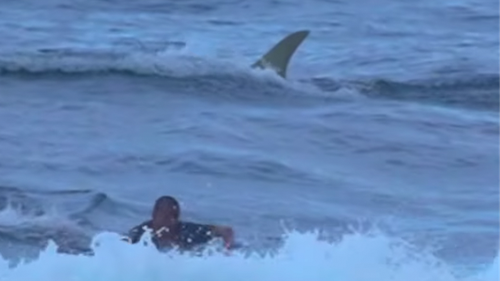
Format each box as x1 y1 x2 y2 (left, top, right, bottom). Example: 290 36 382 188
128 221 214 249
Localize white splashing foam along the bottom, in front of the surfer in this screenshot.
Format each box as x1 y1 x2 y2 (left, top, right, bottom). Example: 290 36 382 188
0 230 500 281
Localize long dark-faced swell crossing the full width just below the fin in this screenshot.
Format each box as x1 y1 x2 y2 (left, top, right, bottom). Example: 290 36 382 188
0 50 500 111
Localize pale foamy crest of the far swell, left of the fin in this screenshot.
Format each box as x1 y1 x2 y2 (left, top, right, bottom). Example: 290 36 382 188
0 49 270 77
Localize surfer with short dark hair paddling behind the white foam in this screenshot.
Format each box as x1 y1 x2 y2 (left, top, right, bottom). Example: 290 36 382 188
126 196 234 249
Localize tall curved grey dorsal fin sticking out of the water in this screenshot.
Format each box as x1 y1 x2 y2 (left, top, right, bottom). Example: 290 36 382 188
252 30 309 79
